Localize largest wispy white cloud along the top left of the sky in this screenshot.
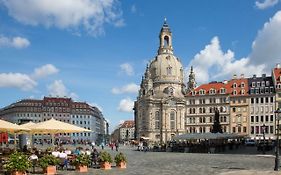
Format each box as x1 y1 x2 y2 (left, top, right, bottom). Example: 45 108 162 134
2 0 124 36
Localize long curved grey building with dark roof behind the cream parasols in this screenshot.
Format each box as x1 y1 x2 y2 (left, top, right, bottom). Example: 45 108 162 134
0 97 107 141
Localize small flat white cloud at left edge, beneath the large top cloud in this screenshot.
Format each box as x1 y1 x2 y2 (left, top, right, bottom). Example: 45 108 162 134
0 36 30 49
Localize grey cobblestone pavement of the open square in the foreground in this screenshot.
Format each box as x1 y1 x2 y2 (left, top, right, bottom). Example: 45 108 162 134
28 147 281 175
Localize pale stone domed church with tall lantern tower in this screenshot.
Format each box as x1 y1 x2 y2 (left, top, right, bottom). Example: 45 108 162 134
134 19 186 143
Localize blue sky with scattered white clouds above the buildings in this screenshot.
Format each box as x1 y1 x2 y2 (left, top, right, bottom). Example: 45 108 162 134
0 0 281 131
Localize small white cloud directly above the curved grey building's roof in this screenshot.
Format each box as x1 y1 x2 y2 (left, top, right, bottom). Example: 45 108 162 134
47 80 78 100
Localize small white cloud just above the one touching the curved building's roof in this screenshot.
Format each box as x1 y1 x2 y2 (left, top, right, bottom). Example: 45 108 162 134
32 64 59 79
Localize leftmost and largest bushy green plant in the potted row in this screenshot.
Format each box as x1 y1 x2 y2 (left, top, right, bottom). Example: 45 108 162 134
4 152 31 175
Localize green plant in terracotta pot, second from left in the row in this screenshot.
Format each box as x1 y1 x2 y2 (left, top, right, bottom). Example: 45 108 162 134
39 155 59 175
